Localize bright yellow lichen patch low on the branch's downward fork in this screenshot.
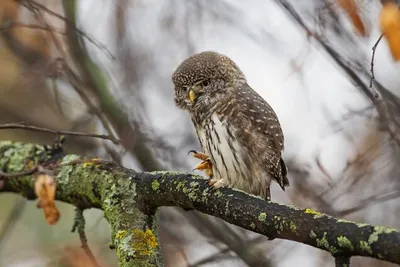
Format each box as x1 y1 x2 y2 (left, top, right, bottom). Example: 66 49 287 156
132 228 158 256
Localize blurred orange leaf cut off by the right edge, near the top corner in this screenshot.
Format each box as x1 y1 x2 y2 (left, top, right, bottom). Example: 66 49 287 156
380 2 400 61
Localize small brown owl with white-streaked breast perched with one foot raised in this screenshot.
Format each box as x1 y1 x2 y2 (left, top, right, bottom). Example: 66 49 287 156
172 52 289 200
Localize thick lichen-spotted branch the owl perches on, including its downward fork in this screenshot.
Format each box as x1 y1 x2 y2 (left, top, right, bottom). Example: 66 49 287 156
0 141 400 266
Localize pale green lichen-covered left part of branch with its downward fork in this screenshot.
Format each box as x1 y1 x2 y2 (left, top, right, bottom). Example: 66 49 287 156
0 141 162 267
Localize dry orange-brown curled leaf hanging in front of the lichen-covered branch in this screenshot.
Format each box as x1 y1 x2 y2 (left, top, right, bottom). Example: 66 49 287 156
35 174 60 224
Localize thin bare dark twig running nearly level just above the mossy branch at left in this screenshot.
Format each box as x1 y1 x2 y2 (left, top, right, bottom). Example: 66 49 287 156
0 123 121 144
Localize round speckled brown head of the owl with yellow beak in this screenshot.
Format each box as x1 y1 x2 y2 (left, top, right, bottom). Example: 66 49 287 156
172 51 246 111
